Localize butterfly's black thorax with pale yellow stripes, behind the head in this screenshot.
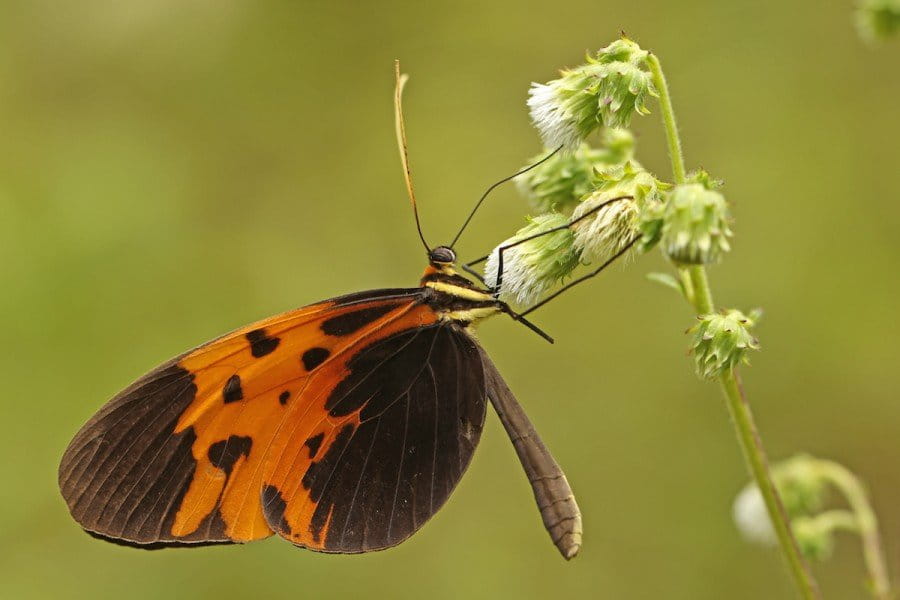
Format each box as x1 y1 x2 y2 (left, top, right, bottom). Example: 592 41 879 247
420 262 502 326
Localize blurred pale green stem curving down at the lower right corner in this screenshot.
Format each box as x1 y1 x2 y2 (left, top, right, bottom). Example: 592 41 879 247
816 460 891 600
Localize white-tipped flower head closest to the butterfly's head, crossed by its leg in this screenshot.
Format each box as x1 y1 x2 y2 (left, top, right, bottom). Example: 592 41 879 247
484 213 579 305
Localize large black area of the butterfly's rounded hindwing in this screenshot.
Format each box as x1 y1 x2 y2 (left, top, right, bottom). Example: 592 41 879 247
273 323 486 553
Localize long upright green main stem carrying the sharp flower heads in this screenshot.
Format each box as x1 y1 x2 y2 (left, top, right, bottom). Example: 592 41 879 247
647 53 821 600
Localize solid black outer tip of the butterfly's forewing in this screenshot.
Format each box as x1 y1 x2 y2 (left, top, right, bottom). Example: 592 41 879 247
59 359 231 548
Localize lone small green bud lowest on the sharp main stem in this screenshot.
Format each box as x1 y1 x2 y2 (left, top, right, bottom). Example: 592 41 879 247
688 309 759 379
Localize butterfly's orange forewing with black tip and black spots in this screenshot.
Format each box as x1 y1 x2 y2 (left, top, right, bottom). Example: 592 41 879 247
59 289 450 545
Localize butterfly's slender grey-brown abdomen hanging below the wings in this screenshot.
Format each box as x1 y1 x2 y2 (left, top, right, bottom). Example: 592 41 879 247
481 350 582 560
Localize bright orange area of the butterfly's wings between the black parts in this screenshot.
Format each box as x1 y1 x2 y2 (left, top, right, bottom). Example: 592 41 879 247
171 299 437 547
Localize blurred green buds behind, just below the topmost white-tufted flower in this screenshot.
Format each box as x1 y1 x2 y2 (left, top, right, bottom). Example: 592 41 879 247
516 129 634 213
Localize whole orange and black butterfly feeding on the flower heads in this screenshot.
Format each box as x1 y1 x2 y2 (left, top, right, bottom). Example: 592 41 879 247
59 61 581 558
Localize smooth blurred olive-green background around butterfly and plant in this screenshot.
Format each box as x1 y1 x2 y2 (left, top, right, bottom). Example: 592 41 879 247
0 0 900 600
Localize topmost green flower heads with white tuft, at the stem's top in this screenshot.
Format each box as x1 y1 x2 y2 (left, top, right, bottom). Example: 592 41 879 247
528 38 658 149
